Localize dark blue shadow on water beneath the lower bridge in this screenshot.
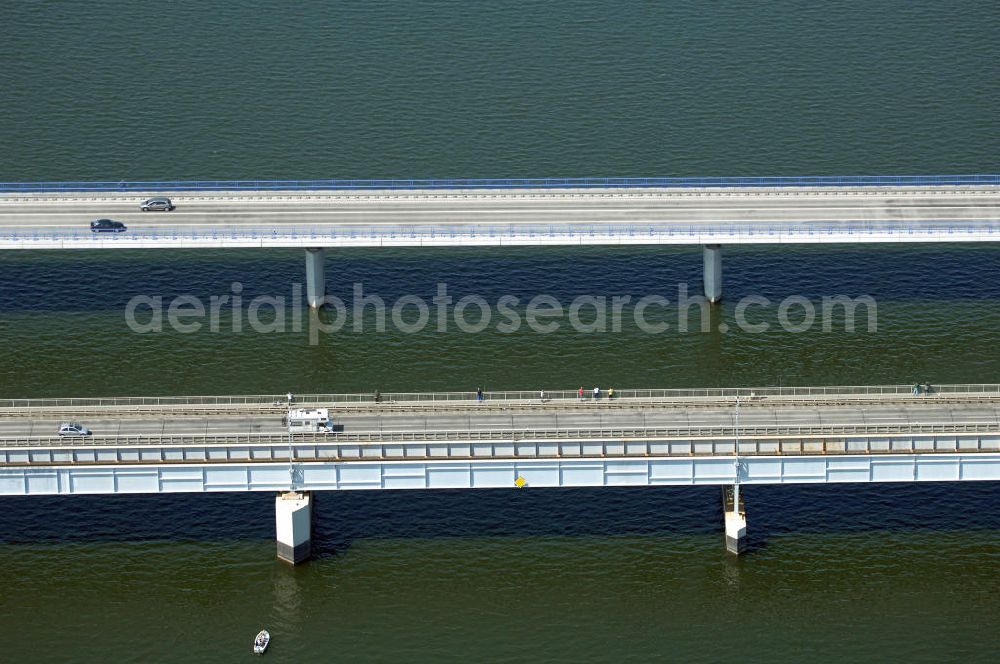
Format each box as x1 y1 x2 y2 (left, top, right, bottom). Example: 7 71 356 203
0 482 1000 557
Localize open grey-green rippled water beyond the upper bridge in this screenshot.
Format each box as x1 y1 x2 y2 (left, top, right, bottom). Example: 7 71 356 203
0 0 1000 180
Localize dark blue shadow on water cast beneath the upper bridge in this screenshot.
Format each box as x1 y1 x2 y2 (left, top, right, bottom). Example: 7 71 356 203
0 244 1000 314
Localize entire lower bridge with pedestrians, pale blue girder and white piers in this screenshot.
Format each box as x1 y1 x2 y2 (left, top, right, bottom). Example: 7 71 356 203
0 385 1000 562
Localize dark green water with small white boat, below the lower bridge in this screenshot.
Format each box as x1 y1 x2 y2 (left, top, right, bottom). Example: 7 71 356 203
0 484 1000 662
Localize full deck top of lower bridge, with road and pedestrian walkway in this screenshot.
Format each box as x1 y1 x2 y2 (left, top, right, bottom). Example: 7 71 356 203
0 385 1000 452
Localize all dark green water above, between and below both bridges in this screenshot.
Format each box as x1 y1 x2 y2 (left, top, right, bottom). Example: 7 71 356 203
0 1 1000 662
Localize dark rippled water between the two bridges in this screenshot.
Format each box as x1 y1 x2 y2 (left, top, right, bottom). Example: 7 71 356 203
0 245 1000 397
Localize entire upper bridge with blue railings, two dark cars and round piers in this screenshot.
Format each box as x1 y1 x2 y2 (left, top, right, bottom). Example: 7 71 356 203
0 175 1000 306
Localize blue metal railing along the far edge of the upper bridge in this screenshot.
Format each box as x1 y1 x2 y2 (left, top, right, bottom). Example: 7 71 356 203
0 174 1000 192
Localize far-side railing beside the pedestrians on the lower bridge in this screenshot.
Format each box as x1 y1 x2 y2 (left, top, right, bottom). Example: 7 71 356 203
0 383 1000 409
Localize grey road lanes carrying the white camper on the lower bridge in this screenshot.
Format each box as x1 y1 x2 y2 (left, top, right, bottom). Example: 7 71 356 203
0 399 1000 446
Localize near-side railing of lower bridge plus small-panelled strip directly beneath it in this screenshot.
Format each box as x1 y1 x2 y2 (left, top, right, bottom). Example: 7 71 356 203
0 422 1000 465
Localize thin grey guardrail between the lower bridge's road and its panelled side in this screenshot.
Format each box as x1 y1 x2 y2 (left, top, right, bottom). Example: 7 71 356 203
0 422 1000 448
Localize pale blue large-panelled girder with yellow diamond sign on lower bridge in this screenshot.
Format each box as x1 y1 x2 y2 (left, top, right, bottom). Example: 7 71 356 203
0 452 1000 495
